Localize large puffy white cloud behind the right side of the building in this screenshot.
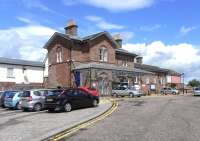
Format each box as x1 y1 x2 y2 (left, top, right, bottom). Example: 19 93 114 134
123 41 200 80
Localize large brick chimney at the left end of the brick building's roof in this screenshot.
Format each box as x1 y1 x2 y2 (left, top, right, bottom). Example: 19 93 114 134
65 19 78 36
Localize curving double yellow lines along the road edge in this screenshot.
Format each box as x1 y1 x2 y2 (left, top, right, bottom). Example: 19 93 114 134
46 99 118 141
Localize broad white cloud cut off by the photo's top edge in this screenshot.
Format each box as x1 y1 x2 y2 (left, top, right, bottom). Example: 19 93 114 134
64 0 155 12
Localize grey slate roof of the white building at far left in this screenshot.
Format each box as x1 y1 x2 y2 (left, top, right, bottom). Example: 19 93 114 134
0 57 44 67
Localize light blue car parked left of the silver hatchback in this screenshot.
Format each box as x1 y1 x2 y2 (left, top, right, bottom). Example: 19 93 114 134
4 91 22 110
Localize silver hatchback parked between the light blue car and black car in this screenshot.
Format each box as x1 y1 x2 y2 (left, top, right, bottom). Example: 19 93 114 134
21 89 49 111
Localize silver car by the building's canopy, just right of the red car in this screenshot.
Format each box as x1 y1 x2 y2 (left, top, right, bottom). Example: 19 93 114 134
111 86 143 97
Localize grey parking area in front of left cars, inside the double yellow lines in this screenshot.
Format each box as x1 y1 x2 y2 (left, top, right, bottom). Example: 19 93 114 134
0 98 112 141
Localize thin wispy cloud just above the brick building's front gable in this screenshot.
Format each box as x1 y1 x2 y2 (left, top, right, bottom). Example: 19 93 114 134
85 16 125 30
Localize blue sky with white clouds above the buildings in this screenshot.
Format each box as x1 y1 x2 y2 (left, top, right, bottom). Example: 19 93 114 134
0 0 200 80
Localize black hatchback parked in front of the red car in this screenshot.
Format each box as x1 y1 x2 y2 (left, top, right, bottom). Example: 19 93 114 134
45 87 99 112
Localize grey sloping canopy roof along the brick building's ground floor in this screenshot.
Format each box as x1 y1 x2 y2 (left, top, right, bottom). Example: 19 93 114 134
74 62 154 74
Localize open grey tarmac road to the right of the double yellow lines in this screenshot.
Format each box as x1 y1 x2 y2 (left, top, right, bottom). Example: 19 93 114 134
63 95 200 141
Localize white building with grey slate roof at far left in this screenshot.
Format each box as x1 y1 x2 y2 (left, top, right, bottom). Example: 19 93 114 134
0 57 44 90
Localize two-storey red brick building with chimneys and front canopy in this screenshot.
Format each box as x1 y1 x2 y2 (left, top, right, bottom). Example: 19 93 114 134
44 20 183 95
